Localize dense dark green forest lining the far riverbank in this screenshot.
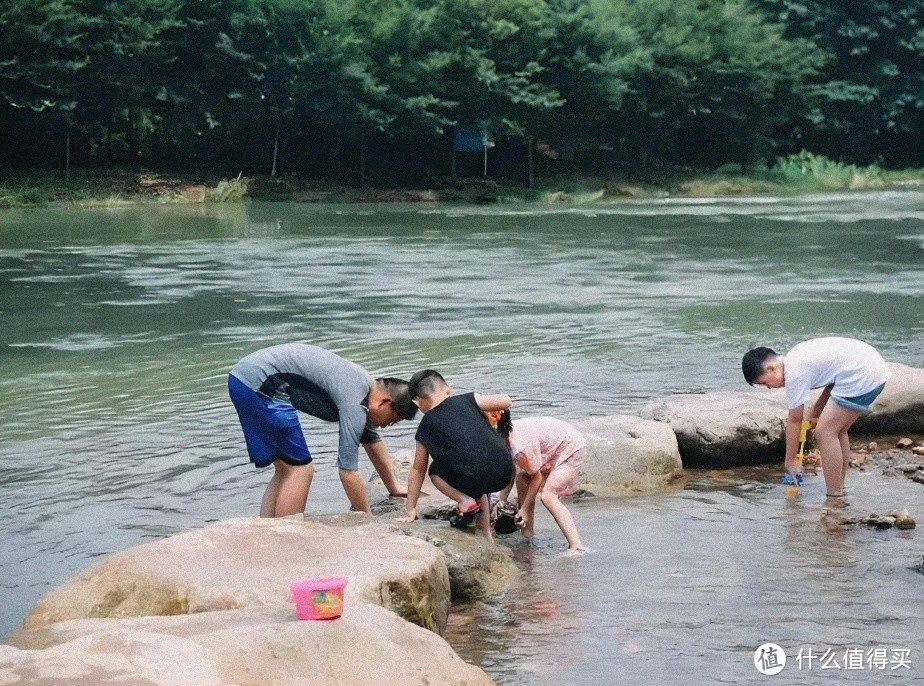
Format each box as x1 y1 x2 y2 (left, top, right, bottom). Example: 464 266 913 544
0 0 924 182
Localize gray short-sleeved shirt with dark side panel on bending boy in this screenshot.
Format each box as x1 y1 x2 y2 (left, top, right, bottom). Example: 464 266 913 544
231 343 381 471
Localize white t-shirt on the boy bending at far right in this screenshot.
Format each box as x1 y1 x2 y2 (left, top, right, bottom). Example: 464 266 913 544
783 337 892 410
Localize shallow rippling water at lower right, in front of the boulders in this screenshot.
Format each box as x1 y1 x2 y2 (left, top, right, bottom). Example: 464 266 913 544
447 469 924 685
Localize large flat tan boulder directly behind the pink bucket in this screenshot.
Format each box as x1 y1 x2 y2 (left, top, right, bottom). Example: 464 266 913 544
23 517 449 632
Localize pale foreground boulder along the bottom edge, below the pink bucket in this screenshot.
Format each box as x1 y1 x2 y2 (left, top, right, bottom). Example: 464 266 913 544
0 599 493 686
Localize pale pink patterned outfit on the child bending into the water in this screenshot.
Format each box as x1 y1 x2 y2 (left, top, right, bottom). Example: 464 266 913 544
510 417 587 496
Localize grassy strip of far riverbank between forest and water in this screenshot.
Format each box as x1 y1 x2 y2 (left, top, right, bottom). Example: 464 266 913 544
0 153 924 208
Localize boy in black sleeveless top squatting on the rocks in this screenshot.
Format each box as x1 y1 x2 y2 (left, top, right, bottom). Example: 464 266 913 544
404 369 513 541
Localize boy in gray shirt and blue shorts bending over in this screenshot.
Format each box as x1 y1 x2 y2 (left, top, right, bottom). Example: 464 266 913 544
228 343 417 517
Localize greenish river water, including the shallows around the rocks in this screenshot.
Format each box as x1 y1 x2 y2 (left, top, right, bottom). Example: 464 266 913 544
0 191 924 684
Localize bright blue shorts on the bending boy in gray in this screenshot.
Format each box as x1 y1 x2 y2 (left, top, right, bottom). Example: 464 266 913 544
228 375 311 467
